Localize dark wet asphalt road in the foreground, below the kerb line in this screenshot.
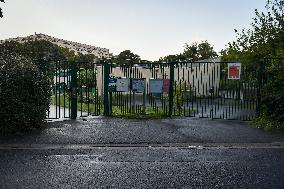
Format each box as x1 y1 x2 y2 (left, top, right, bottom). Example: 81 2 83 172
0 147 284 189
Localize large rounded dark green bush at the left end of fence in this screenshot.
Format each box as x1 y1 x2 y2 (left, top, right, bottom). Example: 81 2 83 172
0 52 50 134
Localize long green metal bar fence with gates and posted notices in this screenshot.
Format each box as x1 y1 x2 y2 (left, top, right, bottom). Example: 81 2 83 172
47 61 259 120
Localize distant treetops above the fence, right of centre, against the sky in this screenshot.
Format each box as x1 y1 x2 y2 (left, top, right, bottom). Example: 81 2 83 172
160 40 218 62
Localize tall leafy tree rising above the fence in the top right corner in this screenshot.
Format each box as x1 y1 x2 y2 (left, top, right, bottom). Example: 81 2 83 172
221 0 284 64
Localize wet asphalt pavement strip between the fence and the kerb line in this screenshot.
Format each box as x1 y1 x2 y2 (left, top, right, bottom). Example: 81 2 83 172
0 118 284 145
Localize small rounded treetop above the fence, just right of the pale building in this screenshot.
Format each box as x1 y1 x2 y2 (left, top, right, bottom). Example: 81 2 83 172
113 50 141 64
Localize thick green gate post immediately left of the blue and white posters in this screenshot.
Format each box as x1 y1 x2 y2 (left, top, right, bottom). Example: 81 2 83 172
103 60 110 116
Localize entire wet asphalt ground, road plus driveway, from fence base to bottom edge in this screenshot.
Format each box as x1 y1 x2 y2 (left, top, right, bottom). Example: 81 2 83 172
0 118 284 189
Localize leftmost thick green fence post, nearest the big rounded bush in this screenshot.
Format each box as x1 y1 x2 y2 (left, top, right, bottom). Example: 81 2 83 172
70 61 78 119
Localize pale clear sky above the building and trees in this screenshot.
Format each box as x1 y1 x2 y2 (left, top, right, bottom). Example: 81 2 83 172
0 0 266 60
